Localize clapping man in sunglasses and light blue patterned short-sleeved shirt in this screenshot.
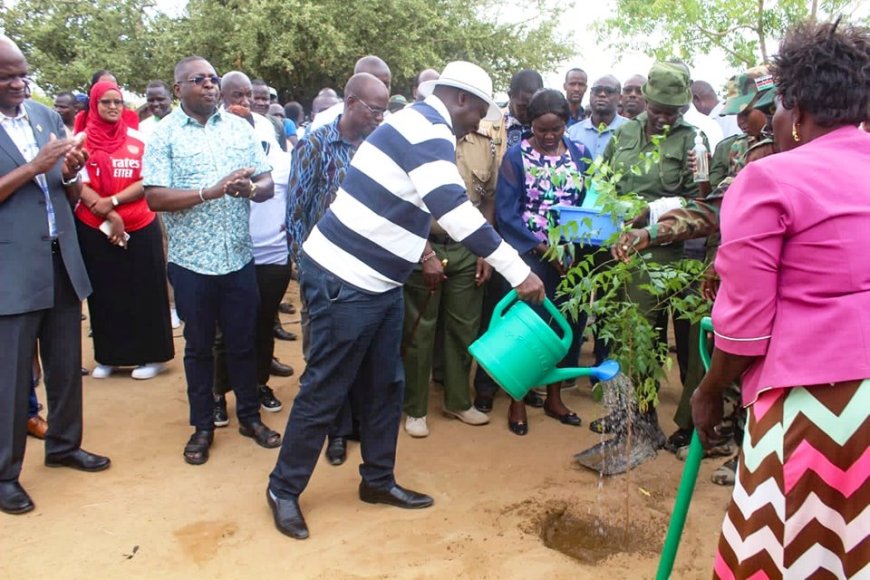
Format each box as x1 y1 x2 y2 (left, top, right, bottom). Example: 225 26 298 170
142 56 281 465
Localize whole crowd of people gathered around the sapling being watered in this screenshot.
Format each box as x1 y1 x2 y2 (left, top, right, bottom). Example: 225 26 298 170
0 17 870 577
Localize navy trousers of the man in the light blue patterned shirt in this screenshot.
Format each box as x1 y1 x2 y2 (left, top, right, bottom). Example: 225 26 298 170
168 262 260 429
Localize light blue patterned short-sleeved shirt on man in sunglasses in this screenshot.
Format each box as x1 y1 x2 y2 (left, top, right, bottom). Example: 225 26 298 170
142 107 272 276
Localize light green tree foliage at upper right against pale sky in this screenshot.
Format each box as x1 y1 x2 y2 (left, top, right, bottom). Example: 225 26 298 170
596 0 864 68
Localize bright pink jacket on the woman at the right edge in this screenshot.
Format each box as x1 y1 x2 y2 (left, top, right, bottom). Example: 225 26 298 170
713 127 870 405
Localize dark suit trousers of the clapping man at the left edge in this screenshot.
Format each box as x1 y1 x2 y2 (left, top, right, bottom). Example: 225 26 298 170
0 253 82 482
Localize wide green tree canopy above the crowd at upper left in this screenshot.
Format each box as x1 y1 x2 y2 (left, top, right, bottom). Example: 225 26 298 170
0 0 574 100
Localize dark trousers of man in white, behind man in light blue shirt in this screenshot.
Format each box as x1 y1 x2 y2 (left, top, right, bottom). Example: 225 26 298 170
214 262 290 395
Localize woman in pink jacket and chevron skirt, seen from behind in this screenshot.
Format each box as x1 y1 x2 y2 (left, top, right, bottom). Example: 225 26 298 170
692 21 870 578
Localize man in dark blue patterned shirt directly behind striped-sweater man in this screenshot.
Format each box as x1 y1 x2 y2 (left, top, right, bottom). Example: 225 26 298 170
287 73 390 465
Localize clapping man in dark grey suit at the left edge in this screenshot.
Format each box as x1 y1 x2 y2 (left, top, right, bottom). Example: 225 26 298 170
0 35 109 514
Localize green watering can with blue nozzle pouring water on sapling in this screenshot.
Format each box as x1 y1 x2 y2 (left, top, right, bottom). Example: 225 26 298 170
468 290 619 401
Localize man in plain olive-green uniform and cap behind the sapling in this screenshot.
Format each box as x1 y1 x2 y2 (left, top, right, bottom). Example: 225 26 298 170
590 63 698 468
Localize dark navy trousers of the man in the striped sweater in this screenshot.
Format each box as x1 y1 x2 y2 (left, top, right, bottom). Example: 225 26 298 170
269 256 404 498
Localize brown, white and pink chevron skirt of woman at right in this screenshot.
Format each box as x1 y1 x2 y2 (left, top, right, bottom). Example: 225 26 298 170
713 379 870 580
